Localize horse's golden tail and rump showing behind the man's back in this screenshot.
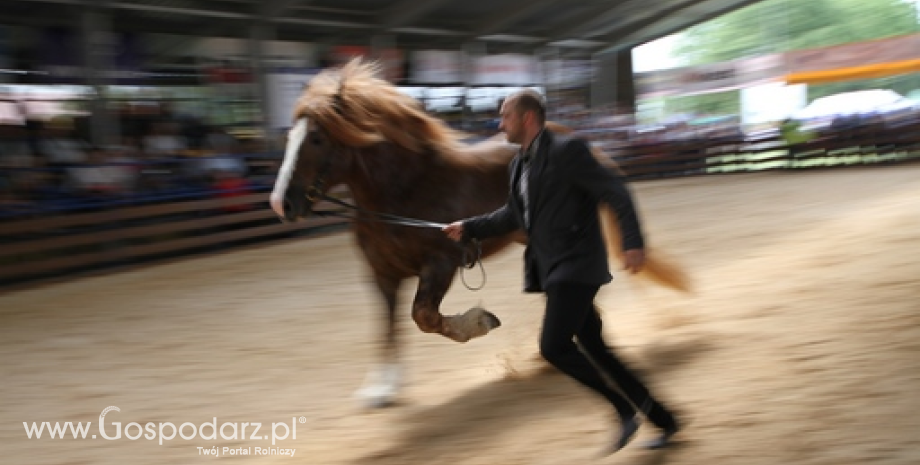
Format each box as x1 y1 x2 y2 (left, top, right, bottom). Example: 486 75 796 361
546 121 691 292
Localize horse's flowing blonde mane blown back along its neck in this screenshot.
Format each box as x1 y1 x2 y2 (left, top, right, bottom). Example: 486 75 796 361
294 58 513 164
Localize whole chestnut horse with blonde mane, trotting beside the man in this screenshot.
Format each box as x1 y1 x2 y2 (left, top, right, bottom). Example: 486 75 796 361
269 59 689 407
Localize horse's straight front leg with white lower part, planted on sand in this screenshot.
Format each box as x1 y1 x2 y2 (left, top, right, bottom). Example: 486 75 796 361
355 273 402 408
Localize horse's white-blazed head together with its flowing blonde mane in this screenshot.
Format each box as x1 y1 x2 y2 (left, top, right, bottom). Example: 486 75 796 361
271 60 468 221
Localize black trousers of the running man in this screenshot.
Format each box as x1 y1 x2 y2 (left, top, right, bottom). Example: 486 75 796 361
540 283 675 428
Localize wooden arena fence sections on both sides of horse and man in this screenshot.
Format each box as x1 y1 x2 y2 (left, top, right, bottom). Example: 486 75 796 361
0 122 920 287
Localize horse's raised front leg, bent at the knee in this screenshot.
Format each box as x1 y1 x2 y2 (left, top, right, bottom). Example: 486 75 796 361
412 260 501 342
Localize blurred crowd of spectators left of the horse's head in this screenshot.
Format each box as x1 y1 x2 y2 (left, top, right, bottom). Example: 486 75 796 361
0 103 276 218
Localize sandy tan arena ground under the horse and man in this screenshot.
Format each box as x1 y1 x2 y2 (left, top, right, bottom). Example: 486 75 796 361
0 165 920 465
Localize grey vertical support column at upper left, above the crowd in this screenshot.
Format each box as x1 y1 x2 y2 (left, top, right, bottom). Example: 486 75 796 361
81 0 120 146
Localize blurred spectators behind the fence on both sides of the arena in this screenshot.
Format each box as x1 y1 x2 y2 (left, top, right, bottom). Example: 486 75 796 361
0 91 920 219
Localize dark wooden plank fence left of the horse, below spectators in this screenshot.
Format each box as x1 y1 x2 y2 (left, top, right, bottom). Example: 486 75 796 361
0 185 347 286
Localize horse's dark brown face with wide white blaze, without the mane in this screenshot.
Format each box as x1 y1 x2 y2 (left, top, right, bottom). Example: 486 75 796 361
270 116 347 221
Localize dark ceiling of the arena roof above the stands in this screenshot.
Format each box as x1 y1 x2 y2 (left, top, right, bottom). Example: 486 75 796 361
0 0 758 70
